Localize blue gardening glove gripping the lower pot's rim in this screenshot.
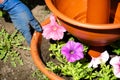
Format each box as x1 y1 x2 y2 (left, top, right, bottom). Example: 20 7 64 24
0 0 42 45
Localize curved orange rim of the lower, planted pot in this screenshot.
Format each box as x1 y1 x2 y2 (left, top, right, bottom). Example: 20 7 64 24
30 18 64 80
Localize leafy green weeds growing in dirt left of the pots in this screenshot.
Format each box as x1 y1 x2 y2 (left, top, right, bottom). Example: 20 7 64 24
0 29 27 67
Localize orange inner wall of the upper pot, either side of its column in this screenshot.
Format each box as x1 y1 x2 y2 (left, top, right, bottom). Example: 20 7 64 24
52 0 120 23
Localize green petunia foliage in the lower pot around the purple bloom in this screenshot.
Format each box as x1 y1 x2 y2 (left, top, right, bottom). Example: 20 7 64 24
47 33 116 80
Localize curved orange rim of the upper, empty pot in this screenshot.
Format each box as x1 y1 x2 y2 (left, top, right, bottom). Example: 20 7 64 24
45 0 120 29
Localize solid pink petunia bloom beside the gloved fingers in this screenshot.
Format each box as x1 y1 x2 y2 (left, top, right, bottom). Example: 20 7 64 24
42 15 66 40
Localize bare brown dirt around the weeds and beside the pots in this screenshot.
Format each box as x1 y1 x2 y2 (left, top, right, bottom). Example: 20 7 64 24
0 0 49 80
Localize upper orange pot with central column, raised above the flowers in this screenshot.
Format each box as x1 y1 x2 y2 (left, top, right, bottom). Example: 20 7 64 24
45 0 120 57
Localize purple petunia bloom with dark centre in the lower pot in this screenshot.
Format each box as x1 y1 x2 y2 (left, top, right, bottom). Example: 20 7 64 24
61 41 84 62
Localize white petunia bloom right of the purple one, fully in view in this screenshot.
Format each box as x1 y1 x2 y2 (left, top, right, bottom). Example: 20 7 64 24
88 51 109 68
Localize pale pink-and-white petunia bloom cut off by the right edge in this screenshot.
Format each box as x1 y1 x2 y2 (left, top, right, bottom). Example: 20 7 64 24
110 56 120 78
